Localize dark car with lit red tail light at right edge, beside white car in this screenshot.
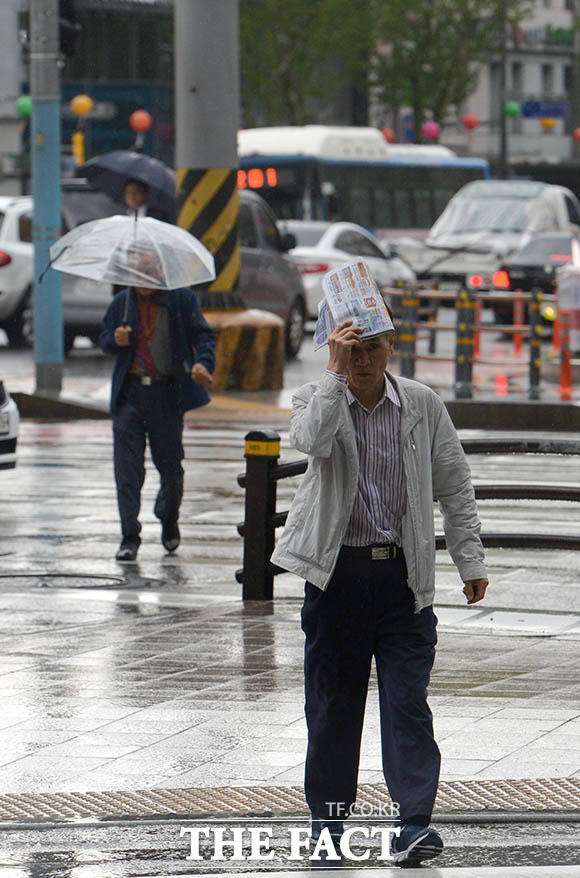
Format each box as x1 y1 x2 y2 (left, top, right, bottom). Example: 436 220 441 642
492 233 572 324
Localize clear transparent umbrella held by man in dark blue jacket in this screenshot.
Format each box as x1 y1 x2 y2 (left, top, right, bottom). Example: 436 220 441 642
50 216 215 290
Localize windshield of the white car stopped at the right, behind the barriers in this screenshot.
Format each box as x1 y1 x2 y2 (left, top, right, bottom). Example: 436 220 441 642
430 197 558 238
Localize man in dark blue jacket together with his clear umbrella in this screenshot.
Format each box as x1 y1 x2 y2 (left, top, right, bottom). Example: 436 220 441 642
51 215 215 561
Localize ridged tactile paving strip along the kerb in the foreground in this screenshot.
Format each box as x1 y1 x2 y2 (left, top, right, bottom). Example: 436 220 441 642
0 778 580 822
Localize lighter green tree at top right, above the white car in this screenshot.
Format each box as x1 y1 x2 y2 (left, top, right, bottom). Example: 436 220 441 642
372 0 536 139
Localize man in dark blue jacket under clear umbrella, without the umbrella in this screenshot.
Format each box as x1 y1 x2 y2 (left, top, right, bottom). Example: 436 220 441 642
99 239 215 561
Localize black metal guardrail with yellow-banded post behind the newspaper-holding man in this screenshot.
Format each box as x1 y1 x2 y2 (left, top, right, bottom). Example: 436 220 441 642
236 430 580 600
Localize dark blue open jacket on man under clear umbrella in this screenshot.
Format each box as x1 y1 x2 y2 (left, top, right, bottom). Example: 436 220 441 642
99 288 215 414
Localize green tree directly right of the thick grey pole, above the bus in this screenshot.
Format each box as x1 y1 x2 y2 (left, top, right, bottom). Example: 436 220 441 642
240 0 372 127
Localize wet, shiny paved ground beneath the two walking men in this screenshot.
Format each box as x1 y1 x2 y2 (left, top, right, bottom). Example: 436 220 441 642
0 324 580 878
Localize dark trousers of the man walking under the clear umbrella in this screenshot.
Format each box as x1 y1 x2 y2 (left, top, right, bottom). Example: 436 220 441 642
113 378 183 537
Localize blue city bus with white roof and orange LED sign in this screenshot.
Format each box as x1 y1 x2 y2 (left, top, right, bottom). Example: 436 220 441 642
238 125 490 237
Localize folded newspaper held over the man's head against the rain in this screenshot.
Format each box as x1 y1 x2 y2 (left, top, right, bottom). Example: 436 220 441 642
314 259 394 351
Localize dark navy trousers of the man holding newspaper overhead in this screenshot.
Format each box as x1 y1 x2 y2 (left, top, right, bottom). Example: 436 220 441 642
302 547 440 823
